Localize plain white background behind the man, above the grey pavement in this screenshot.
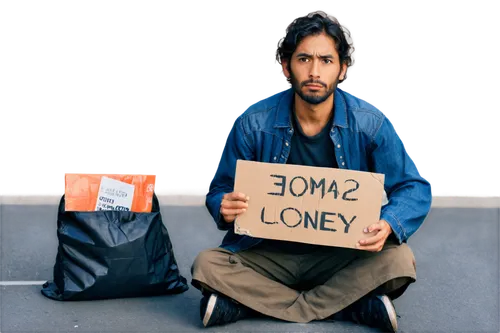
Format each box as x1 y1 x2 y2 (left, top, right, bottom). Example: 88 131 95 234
0 3 492 192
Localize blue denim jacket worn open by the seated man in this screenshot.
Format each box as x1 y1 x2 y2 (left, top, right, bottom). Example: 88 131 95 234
206 88 433 252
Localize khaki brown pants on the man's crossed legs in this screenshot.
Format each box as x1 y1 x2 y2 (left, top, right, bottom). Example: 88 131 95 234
191 238 416 323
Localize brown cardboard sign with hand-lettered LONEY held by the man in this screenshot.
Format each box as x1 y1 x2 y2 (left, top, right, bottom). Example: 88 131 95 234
234 160 385 248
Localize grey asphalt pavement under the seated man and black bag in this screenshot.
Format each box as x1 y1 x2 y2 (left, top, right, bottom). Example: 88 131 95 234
0 195 500 333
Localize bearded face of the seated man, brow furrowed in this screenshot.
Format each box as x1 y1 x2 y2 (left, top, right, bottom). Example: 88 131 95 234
282 33 346 104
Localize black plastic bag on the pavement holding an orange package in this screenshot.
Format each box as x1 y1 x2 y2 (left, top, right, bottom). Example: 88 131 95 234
41 193 189 301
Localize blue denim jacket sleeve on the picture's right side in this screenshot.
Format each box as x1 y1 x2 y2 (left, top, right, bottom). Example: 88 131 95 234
371 116 433 244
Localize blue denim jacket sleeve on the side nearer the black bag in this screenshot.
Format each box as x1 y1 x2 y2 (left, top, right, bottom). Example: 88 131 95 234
205 114 254 230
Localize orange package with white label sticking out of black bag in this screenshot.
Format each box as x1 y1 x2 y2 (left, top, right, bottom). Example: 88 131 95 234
62 170 158 213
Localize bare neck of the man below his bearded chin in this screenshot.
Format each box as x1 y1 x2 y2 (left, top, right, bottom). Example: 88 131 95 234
294 94 334 126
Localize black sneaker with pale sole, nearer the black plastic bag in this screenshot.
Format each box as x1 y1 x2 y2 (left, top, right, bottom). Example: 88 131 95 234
200 294 255 327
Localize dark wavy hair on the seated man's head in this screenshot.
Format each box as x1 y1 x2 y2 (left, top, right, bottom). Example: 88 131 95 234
274 9 356 77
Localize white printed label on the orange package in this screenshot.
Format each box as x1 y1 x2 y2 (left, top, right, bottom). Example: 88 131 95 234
95 177 135 211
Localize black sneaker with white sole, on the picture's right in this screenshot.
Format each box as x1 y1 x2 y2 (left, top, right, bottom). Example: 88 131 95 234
342 295 399 333
